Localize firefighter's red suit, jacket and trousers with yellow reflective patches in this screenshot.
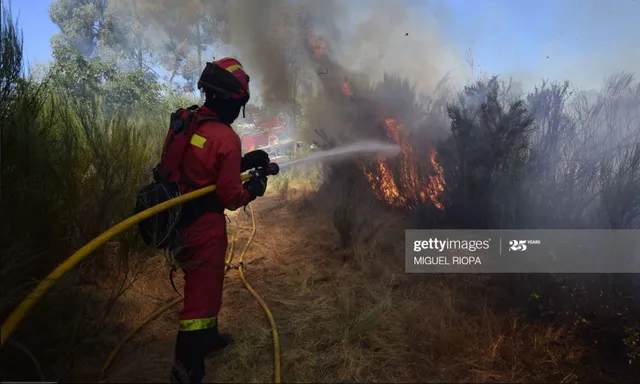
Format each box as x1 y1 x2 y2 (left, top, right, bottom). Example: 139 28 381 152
179 106 251 331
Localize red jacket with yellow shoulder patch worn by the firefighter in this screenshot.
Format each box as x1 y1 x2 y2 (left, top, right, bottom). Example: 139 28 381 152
180 106 250 211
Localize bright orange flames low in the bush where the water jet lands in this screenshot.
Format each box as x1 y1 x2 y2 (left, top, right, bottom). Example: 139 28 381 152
363 118 444 210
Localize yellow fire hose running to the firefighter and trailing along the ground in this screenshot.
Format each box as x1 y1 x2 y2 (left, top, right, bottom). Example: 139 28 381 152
0 174 280 383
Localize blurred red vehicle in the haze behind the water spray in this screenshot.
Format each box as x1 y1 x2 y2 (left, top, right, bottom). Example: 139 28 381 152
241 119 293 163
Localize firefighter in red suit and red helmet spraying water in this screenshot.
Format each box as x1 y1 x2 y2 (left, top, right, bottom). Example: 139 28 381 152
171 58 269 383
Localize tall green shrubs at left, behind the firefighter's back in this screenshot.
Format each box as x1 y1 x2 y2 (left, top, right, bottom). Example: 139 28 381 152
0 3 170 380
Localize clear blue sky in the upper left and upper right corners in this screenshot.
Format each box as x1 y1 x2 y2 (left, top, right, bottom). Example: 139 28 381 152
10 0 640 87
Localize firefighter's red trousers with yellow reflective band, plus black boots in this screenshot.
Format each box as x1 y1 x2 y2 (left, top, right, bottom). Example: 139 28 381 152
171 213 231 383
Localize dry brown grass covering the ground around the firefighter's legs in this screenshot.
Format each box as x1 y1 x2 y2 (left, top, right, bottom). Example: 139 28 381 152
87 184 624 382
